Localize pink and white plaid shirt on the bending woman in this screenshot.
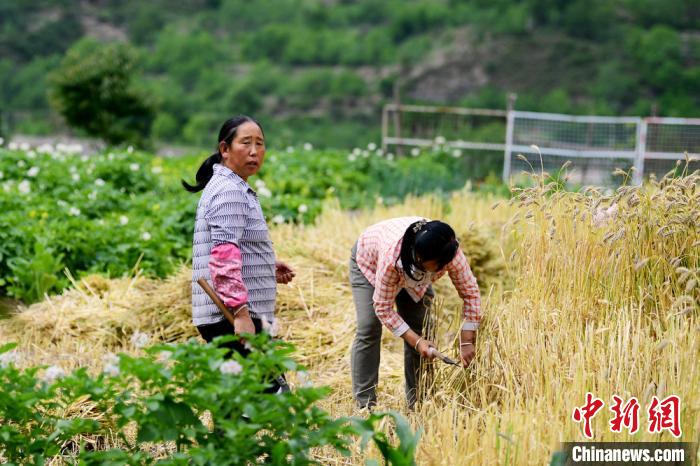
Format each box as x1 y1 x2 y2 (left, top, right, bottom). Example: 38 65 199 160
356 217 481 336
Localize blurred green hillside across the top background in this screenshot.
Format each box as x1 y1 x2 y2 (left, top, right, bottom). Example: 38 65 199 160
0 0 700 147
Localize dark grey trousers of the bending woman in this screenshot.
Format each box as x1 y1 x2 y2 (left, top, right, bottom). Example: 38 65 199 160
350 244 435 408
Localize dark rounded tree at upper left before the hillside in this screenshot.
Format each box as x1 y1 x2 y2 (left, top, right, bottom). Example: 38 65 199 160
49 39 154 146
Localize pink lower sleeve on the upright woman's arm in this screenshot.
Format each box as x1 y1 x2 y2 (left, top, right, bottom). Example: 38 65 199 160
209 243 248 307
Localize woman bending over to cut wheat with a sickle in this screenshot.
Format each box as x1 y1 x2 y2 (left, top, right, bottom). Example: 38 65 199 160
350 217 481 408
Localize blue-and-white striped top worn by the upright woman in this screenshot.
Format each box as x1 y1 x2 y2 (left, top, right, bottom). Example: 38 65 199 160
192 164 277 325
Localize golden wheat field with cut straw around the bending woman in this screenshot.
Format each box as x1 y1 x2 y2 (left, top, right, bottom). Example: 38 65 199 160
0 170 700 465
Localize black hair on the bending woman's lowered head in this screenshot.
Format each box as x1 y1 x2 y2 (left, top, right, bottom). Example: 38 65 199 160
400 220 459 280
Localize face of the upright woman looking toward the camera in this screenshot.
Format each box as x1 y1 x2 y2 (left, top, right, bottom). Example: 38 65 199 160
219 121 265 181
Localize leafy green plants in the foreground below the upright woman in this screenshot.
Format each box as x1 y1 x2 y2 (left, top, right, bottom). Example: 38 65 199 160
0 334 417 465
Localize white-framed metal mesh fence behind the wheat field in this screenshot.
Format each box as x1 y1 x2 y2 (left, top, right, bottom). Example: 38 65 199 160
382 104 700 185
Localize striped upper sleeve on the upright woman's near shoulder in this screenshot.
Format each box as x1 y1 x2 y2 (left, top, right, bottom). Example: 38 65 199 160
204 189 248 246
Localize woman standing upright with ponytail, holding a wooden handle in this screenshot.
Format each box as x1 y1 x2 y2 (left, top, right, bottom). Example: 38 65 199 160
182 115 294 364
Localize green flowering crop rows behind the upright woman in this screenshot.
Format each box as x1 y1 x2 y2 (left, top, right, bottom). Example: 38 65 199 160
0 144 503 302
